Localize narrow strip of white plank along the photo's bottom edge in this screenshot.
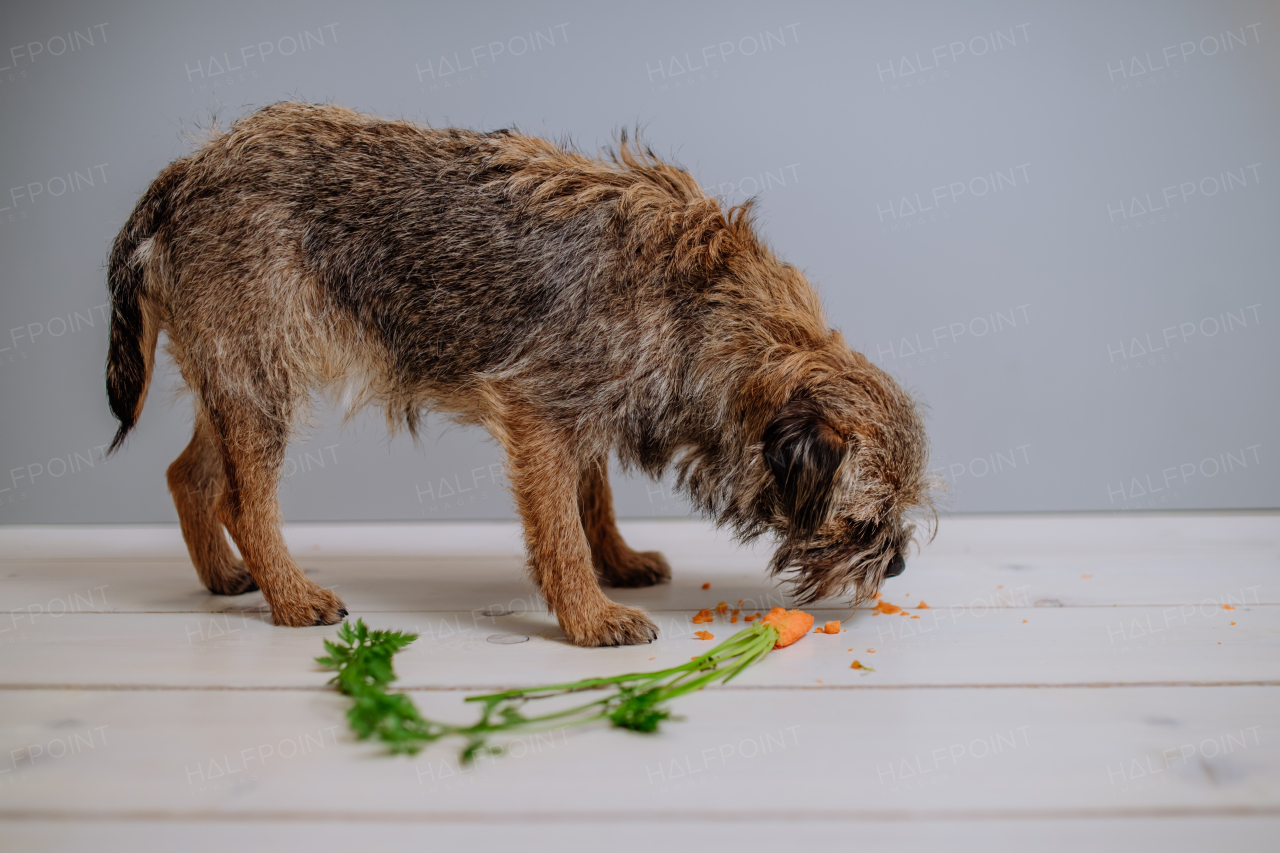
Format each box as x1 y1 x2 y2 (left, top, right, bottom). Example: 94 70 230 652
0 815 1280 853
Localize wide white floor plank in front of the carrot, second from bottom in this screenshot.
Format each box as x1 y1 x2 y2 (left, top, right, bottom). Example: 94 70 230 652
0 686 1280 822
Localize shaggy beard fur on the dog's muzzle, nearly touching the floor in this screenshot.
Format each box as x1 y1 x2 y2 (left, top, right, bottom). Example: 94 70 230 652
769 521 915 607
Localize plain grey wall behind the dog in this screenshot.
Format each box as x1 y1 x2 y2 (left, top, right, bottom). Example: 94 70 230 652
0 0 1280 524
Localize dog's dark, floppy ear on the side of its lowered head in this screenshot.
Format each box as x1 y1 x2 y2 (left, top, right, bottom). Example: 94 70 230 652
763 397 849 535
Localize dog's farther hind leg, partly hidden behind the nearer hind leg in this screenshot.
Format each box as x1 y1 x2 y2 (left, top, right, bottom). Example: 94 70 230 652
168 406 257 596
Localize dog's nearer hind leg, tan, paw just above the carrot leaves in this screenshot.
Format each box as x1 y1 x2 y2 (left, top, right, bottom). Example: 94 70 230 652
206 400 347 628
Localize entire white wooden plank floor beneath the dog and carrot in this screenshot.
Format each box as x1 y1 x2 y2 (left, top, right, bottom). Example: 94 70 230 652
0 514 1280 852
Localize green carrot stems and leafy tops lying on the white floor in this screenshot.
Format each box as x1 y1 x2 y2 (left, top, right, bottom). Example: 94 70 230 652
316 619 778 762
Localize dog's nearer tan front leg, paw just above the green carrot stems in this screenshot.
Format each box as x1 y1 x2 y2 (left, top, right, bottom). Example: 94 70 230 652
503 420 658 646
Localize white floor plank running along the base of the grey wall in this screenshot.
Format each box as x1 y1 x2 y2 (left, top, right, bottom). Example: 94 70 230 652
0 530 1280 613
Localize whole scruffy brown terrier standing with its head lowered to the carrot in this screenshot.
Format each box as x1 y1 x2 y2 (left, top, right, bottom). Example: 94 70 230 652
106 102 929 646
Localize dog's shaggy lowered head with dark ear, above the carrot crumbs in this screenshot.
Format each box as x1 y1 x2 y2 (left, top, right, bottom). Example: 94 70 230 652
759 353 932 603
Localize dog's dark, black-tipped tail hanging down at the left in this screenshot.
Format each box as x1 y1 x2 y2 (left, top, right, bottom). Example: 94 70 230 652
106 161 186 453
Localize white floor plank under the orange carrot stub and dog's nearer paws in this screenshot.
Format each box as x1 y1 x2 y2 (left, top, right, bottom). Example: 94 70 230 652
0 605 1280 688
